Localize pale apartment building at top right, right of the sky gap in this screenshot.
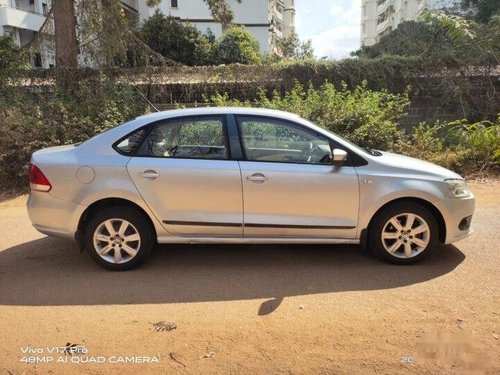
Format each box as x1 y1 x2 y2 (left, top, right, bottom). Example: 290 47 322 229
361 0 460 46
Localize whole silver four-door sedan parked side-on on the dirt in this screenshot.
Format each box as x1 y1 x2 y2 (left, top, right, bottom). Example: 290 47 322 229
28 108 474 270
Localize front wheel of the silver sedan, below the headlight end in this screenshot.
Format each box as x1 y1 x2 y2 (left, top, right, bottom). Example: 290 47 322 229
369 202 438 264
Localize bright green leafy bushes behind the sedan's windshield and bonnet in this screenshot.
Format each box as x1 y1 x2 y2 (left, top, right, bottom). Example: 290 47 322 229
208 82 500 175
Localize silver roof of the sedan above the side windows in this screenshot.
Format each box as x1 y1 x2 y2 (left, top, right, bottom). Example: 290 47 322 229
137 107 299 122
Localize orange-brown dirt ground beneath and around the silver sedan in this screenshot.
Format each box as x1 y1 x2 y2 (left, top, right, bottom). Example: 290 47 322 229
0 181 500 374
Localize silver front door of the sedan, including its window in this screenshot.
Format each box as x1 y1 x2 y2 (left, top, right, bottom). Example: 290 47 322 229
237 116 359 238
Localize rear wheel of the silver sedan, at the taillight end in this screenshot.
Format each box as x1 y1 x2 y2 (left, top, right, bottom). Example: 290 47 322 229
85 207 154 271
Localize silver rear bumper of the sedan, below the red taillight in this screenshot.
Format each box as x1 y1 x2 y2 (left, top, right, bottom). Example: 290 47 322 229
27 191 86 240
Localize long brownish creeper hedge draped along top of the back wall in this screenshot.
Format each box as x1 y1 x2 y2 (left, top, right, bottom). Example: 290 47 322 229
12 56 500 121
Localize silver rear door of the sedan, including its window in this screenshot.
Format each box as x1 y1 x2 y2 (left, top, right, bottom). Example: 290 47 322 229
127 116 243 236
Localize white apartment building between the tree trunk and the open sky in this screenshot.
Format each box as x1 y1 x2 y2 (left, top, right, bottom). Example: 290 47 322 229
138 0 295 53
